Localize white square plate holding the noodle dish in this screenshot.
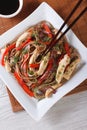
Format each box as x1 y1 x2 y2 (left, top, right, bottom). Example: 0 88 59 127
0 2 87 121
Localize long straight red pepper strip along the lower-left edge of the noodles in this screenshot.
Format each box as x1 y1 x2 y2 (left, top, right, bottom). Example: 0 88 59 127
14 72 34 97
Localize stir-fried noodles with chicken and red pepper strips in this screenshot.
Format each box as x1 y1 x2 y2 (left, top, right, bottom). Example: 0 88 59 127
1 21 80 99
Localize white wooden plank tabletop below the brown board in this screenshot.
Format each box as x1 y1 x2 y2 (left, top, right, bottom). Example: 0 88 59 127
0 80 87 130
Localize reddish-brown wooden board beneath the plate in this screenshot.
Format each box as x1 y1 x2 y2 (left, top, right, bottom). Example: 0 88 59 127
0 0 87 112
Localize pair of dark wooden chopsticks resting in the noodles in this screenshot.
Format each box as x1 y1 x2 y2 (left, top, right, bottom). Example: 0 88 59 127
41 0 87 56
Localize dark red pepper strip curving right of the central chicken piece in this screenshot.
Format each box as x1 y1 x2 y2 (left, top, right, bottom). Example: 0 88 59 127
38 59 53 84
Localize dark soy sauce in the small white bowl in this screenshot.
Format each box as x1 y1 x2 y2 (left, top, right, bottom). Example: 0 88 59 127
0 0 19 15
